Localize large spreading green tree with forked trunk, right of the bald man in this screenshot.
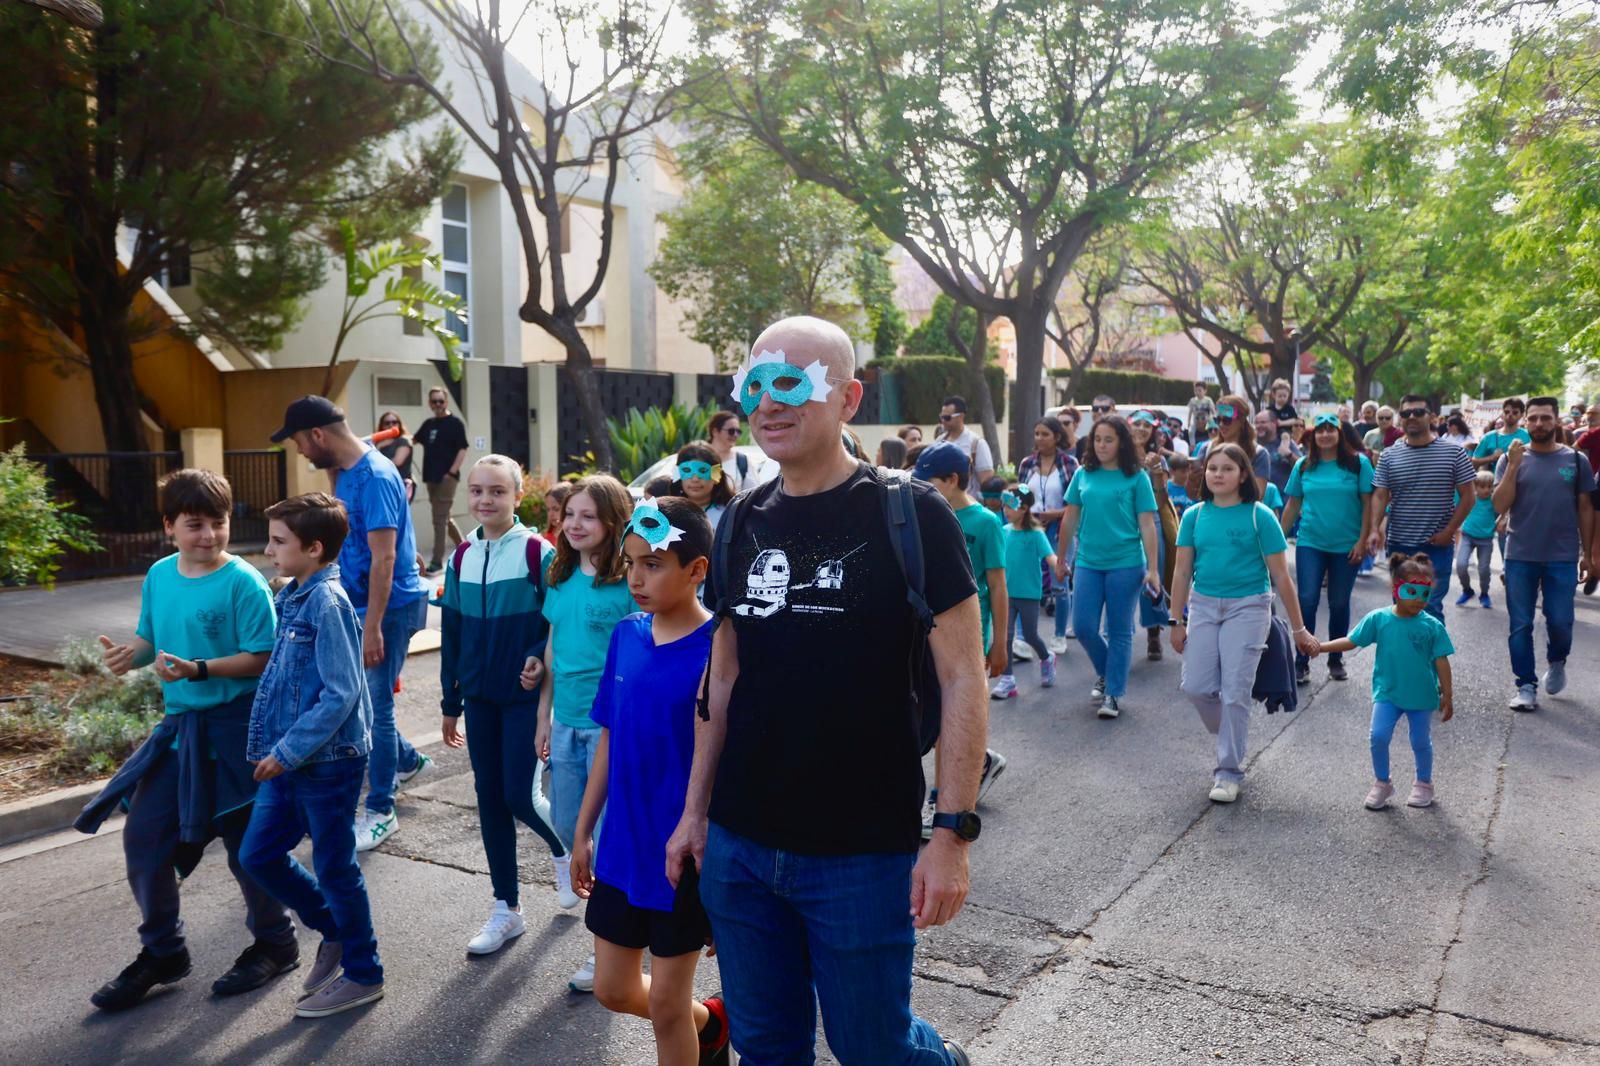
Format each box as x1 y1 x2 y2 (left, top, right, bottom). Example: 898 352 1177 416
690 0 1298 457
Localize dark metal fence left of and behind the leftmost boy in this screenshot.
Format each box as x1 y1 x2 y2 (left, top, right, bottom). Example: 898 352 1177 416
27 451 184 579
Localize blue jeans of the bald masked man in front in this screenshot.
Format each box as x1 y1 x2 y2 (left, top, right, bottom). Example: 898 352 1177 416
699 823 952 1066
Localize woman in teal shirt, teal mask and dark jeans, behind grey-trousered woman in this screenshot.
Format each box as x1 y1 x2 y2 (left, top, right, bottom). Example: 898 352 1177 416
1283 413 1373 685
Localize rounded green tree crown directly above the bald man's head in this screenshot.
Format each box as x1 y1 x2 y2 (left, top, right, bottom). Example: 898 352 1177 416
648 149 904 365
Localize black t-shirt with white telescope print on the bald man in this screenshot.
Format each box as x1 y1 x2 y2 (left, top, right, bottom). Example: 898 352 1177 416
707 467 978 855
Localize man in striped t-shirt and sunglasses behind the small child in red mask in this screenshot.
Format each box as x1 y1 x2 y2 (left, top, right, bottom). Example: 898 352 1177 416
1371 394 1477 621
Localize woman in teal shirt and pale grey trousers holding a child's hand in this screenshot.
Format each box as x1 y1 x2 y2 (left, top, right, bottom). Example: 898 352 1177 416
1173 443 1317 804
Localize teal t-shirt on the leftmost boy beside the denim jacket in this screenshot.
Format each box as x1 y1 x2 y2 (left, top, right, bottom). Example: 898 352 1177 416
134 552 278 714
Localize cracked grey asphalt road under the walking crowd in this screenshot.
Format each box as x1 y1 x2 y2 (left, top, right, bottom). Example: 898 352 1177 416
0 563 1600 1066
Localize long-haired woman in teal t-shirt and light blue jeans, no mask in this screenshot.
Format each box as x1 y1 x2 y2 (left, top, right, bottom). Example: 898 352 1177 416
1056 415 1162 719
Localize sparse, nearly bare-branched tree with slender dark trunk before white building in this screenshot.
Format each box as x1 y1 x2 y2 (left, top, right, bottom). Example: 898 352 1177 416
302 0 677 471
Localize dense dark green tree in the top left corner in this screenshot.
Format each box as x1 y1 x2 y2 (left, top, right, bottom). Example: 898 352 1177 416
0 0 456 460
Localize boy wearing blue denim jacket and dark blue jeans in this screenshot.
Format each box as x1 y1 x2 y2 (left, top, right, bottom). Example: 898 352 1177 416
240 493 384 1018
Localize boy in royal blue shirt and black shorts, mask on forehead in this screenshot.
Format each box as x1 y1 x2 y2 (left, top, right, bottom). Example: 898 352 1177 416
573 496 728 1066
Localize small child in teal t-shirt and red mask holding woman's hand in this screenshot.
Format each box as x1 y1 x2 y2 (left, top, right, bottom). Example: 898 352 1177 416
1322 554 1456 810
